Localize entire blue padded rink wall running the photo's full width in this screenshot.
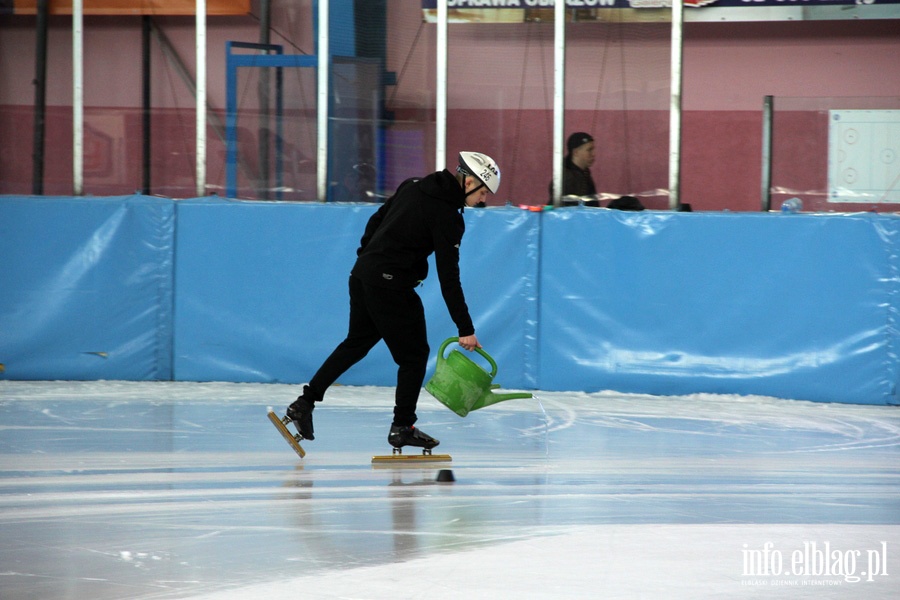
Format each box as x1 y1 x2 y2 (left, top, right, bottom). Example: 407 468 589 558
0 195 900 404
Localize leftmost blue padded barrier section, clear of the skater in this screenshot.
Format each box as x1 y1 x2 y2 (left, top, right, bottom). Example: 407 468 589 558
0 196 174 380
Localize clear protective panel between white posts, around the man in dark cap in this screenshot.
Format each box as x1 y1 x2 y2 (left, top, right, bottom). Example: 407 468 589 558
565 8 671 209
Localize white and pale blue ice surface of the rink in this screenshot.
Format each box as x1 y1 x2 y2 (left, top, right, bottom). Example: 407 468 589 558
0 381 900 600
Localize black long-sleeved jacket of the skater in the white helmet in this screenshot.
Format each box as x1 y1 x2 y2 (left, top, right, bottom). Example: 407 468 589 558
351 169 475 336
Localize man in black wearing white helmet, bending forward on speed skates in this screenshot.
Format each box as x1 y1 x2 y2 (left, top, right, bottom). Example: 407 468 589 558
287 152 500 449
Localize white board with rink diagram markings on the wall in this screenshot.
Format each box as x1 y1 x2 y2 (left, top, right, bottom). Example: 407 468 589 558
828 110 900 204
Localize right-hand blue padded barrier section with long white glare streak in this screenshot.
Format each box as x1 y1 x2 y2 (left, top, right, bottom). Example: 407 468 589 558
540 210 898 404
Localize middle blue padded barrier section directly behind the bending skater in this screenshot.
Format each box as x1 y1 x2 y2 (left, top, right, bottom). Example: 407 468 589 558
175 199 538 387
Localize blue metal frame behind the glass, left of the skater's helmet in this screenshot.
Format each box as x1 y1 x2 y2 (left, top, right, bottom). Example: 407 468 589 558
225 42 318 199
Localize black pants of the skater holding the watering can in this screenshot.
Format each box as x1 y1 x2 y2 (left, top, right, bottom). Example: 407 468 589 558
309 275 429 426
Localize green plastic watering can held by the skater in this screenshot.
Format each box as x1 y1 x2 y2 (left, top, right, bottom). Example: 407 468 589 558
425 337 532 417
